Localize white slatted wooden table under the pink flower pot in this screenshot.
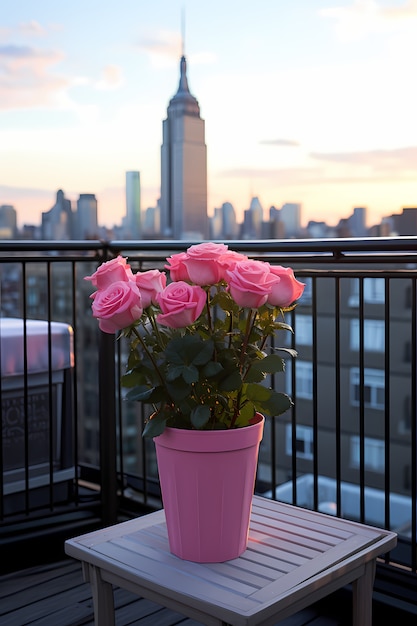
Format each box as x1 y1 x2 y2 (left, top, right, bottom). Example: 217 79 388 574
65 496 397 626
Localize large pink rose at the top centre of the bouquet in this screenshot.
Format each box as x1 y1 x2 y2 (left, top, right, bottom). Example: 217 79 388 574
183 242 227 285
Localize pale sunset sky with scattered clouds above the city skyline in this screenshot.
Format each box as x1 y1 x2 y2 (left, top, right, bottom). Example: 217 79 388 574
0 0 417 227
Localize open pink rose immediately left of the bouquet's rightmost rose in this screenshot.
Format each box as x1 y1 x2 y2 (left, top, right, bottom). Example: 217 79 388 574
226 260 280 309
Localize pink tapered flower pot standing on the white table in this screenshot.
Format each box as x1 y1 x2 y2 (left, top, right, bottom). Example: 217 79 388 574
154 414 265 563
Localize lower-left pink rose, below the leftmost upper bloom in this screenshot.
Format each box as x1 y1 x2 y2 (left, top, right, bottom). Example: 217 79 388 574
91 280 143 334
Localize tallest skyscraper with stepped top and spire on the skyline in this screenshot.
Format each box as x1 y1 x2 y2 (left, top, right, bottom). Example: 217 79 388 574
161 55 208 239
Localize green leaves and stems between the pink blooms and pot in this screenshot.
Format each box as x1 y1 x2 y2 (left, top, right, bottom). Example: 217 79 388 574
122 283 296 437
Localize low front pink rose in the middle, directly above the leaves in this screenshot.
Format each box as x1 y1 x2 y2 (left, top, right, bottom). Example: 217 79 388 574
156 280 207 328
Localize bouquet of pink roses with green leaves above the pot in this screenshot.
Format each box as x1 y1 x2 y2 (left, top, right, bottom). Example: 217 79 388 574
86 242 304 437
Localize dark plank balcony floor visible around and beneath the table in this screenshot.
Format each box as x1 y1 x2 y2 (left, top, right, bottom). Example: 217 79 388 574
0 559 416 626
